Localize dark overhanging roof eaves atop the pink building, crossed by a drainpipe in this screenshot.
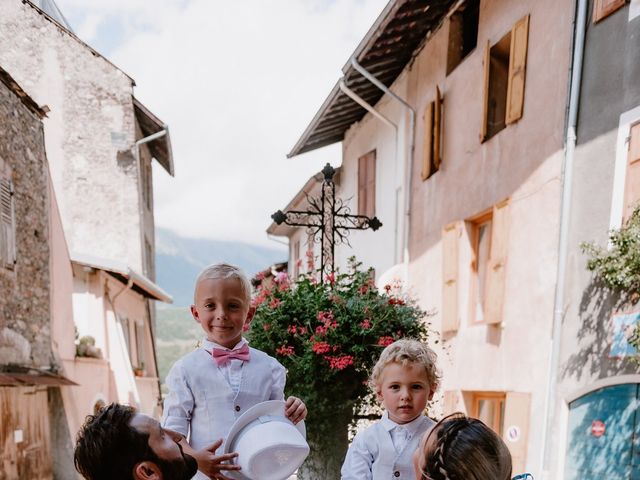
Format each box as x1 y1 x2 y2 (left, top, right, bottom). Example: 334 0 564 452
287 0 457 158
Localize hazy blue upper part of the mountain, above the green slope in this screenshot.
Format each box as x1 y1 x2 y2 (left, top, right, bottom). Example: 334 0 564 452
156 228 287 310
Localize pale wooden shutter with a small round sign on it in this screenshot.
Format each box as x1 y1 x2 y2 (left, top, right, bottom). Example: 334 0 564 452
502 392 531 472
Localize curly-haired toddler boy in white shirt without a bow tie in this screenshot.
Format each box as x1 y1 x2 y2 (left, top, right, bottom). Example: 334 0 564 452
341 340 440 480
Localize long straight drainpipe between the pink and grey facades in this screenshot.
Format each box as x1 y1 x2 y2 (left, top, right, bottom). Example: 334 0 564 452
542 0 587 479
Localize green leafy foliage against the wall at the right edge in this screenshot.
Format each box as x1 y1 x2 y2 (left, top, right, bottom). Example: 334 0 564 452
580 205 640 350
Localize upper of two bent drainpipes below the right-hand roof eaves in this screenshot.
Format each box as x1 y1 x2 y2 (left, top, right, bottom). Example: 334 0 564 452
351 57 416 285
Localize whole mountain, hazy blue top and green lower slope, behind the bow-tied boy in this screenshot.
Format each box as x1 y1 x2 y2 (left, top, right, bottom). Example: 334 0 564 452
156 228 287 382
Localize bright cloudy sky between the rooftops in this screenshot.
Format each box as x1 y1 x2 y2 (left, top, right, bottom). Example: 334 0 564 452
57 0 387 247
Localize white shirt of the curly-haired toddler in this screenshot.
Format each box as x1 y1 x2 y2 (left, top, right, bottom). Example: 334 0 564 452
341 412 434 480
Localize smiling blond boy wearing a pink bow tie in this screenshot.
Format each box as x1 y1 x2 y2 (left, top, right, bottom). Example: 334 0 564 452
162 263 307 479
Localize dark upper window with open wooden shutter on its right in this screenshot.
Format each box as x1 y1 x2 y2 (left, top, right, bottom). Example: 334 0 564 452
480 15 529 141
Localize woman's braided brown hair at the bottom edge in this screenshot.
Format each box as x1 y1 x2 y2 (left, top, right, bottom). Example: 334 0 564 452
421 413 511 480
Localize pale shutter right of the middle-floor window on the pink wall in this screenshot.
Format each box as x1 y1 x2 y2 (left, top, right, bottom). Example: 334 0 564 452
485 200 509 323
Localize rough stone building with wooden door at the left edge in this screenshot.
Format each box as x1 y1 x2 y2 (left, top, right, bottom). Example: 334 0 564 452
0 68 74 480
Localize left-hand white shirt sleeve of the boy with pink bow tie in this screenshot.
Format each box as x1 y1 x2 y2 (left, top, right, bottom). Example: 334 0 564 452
162 361 195 438
